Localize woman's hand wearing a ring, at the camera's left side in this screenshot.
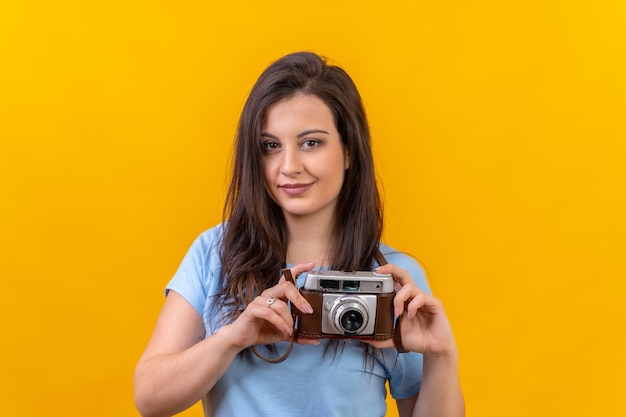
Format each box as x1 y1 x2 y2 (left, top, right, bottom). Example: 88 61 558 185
222 263 315 350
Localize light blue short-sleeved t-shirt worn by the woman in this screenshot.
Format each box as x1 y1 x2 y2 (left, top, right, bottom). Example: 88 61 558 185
167 225 430 417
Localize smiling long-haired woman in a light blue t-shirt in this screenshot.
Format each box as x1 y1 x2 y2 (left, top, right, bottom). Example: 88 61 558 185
135 52 464 417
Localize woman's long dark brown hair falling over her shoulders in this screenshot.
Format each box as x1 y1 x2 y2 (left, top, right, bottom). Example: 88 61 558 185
218 52 383 320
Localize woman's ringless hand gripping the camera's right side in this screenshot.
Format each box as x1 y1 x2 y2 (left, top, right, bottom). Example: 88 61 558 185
367 264 456 354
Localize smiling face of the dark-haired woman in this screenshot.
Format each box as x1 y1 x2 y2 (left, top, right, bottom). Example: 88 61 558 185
261 94 348 222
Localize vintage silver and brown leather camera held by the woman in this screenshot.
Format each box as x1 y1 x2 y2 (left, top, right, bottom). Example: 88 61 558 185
297 271 395 340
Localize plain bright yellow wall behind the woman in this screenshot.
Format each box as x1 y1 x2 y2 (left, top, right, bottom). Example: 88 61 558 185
0 0 626 417
